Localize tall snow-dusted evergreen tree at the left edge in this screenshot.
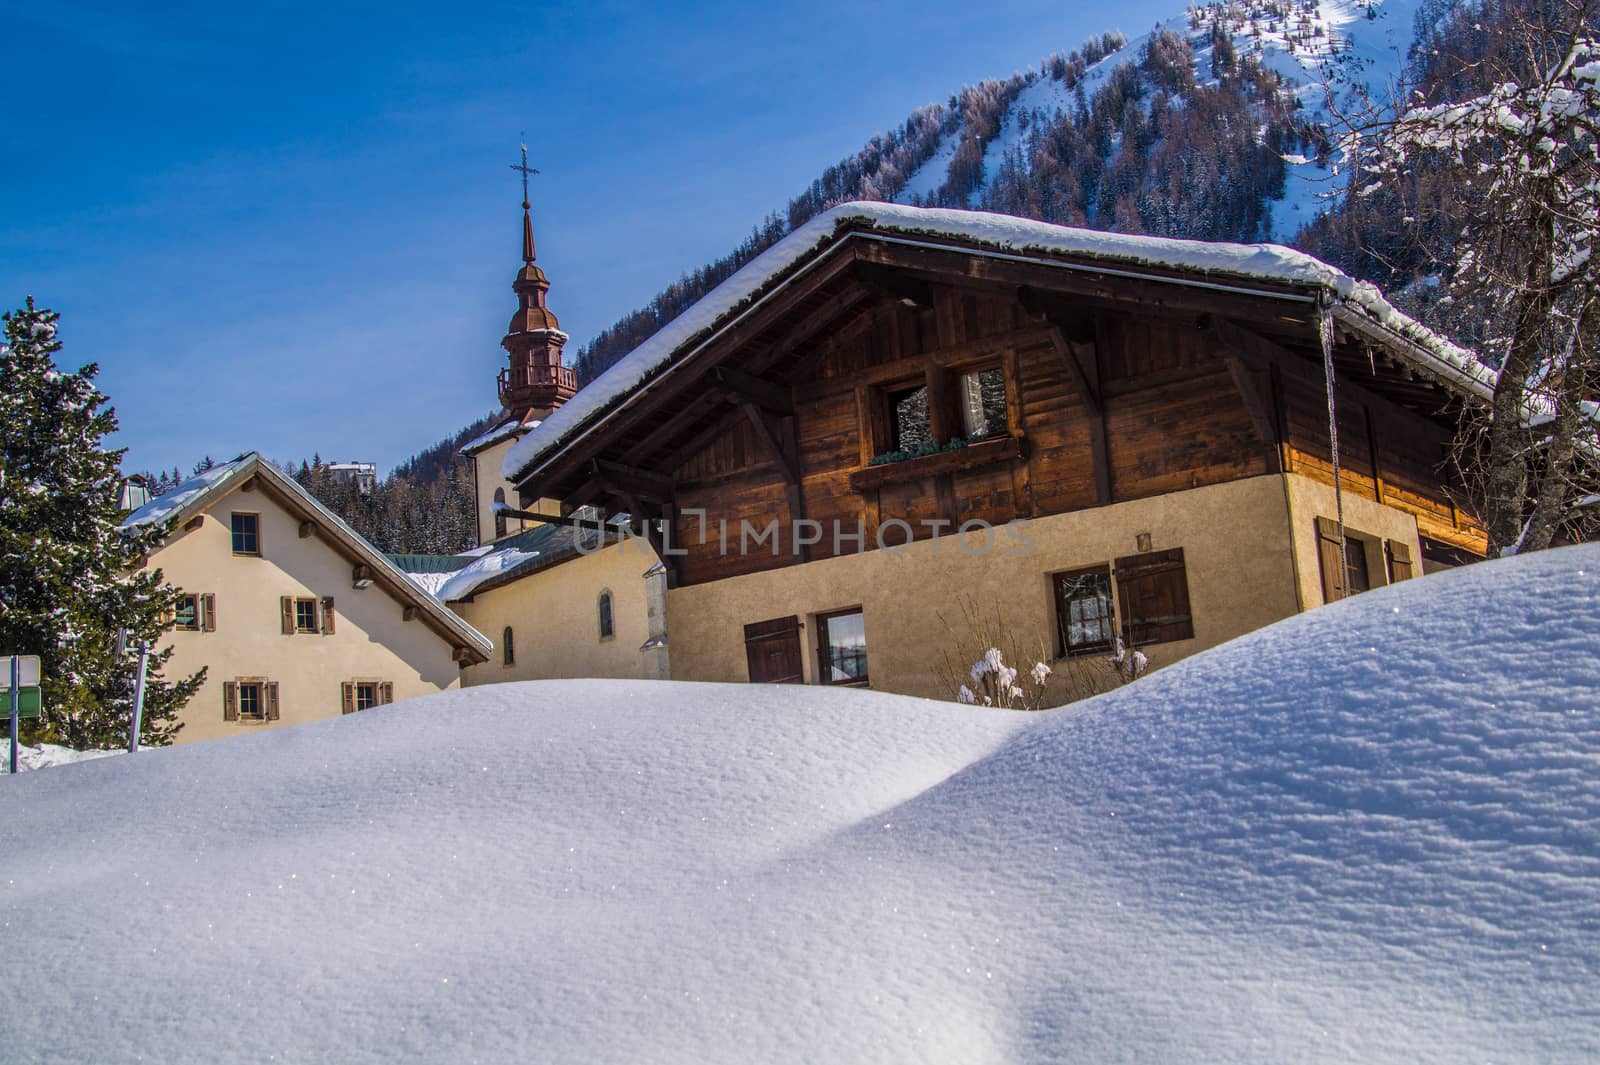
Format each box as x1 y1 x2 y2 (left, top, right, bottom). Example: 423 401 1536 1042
0 297 205 748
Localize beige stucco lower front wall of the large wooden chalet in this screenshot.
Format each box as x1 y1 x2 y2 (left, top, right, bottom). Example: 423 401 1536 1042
667 477 1296 697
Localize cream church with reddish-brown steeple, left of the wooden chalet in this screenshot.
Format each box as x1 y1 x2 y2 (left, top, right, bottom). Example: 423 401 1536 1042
394 183 669 686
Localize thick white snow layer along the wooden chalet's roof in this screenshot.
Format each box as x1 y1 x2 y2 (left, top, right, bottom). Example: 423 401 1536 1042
502 203 1494 481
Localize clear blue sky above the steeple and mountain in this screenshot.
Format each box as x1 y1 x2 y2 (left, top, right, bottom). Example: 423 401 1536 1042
0 0 1181 470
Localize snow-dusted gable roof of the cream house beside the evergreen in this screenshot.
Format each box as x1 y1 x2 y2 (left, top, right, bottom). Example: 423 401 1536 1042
122 451 494 657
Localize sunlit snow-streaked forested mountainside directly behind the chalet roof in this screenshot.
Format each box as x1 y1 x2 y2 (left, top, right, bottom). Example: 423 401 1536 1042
578 0 1446 381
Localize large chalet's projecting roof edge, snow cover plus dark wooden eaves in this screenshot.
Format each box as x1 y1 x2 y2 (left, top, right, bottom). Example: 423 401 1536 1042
504 205 1493 511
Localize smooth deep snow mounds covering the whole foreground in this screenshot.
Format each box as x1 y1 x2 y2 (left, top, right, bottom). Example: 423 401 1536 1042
0 547 1600 1063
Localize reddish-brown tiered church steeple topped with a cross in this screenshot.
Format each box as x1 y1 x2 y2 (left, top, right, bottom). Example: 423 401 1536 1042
499 144 578 421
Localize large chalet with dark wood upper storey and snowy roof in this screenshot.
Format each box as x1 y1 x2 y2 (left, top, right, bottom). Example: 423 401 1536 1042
499 203 1493 697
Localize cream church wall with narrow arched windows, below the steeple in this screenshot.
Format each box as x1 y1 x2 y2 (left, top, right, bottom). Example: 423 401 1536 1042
450 539 667 684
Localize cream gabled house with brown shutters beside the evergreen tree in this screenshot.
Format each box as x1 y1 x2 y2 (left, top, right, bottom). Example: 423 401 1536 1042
125 453 493 744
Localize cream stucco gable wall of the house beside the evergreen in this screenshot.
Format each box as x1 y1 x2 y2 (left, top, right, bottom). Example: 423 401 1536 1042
149 491 461 742
